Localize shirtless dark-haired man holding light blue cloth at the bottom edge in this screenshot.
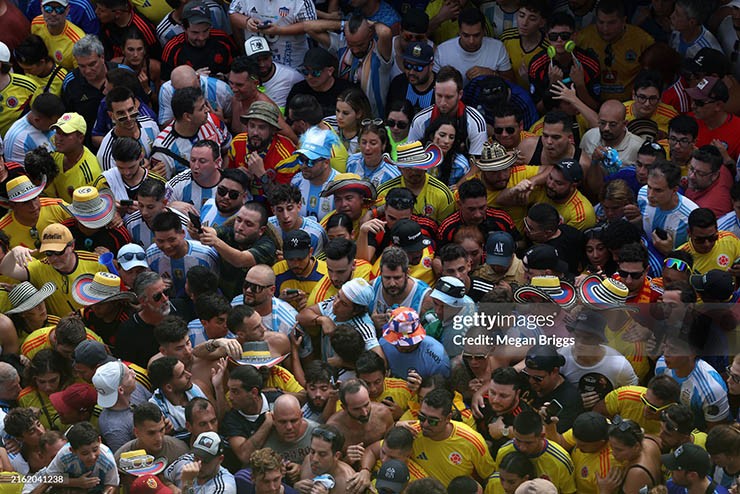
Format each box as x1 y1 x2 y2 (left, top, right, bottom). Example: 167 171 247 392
294 425 355 494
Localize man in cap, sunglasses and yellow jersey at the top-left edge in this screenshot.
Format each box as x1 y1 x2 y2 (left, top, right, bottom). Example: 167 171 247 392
31 0 85 70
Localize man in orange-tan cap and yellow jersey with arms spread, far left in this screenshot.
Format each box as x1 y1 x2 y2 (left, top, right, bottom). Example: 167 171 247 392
0 223 107 316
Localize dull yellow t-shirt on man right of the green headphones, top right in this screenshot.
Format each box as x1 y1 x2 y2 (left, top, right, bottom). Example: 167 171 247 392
578 24 655 101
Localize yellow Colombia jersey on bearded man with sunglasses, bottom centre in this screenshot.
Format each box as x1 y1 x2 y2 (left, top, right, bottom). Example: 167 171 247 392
413 421 496 487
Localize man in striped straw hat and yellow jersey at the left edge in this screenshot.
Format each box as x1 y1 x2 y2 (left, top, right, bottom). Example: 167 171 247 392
0 175 70 257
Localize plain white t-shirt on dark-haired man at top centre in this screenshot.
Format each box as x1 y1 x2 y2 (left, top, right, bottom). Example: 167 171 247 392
434 36 511 86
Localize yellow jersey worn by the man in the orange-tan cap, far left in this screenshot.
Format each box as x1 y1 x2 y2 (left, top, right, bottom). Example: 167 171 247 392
26 250 108 317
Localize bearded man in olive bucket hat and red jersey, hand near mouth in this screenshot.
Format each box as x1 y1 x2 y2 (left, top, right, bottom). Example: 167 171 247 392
227 101 299 198
